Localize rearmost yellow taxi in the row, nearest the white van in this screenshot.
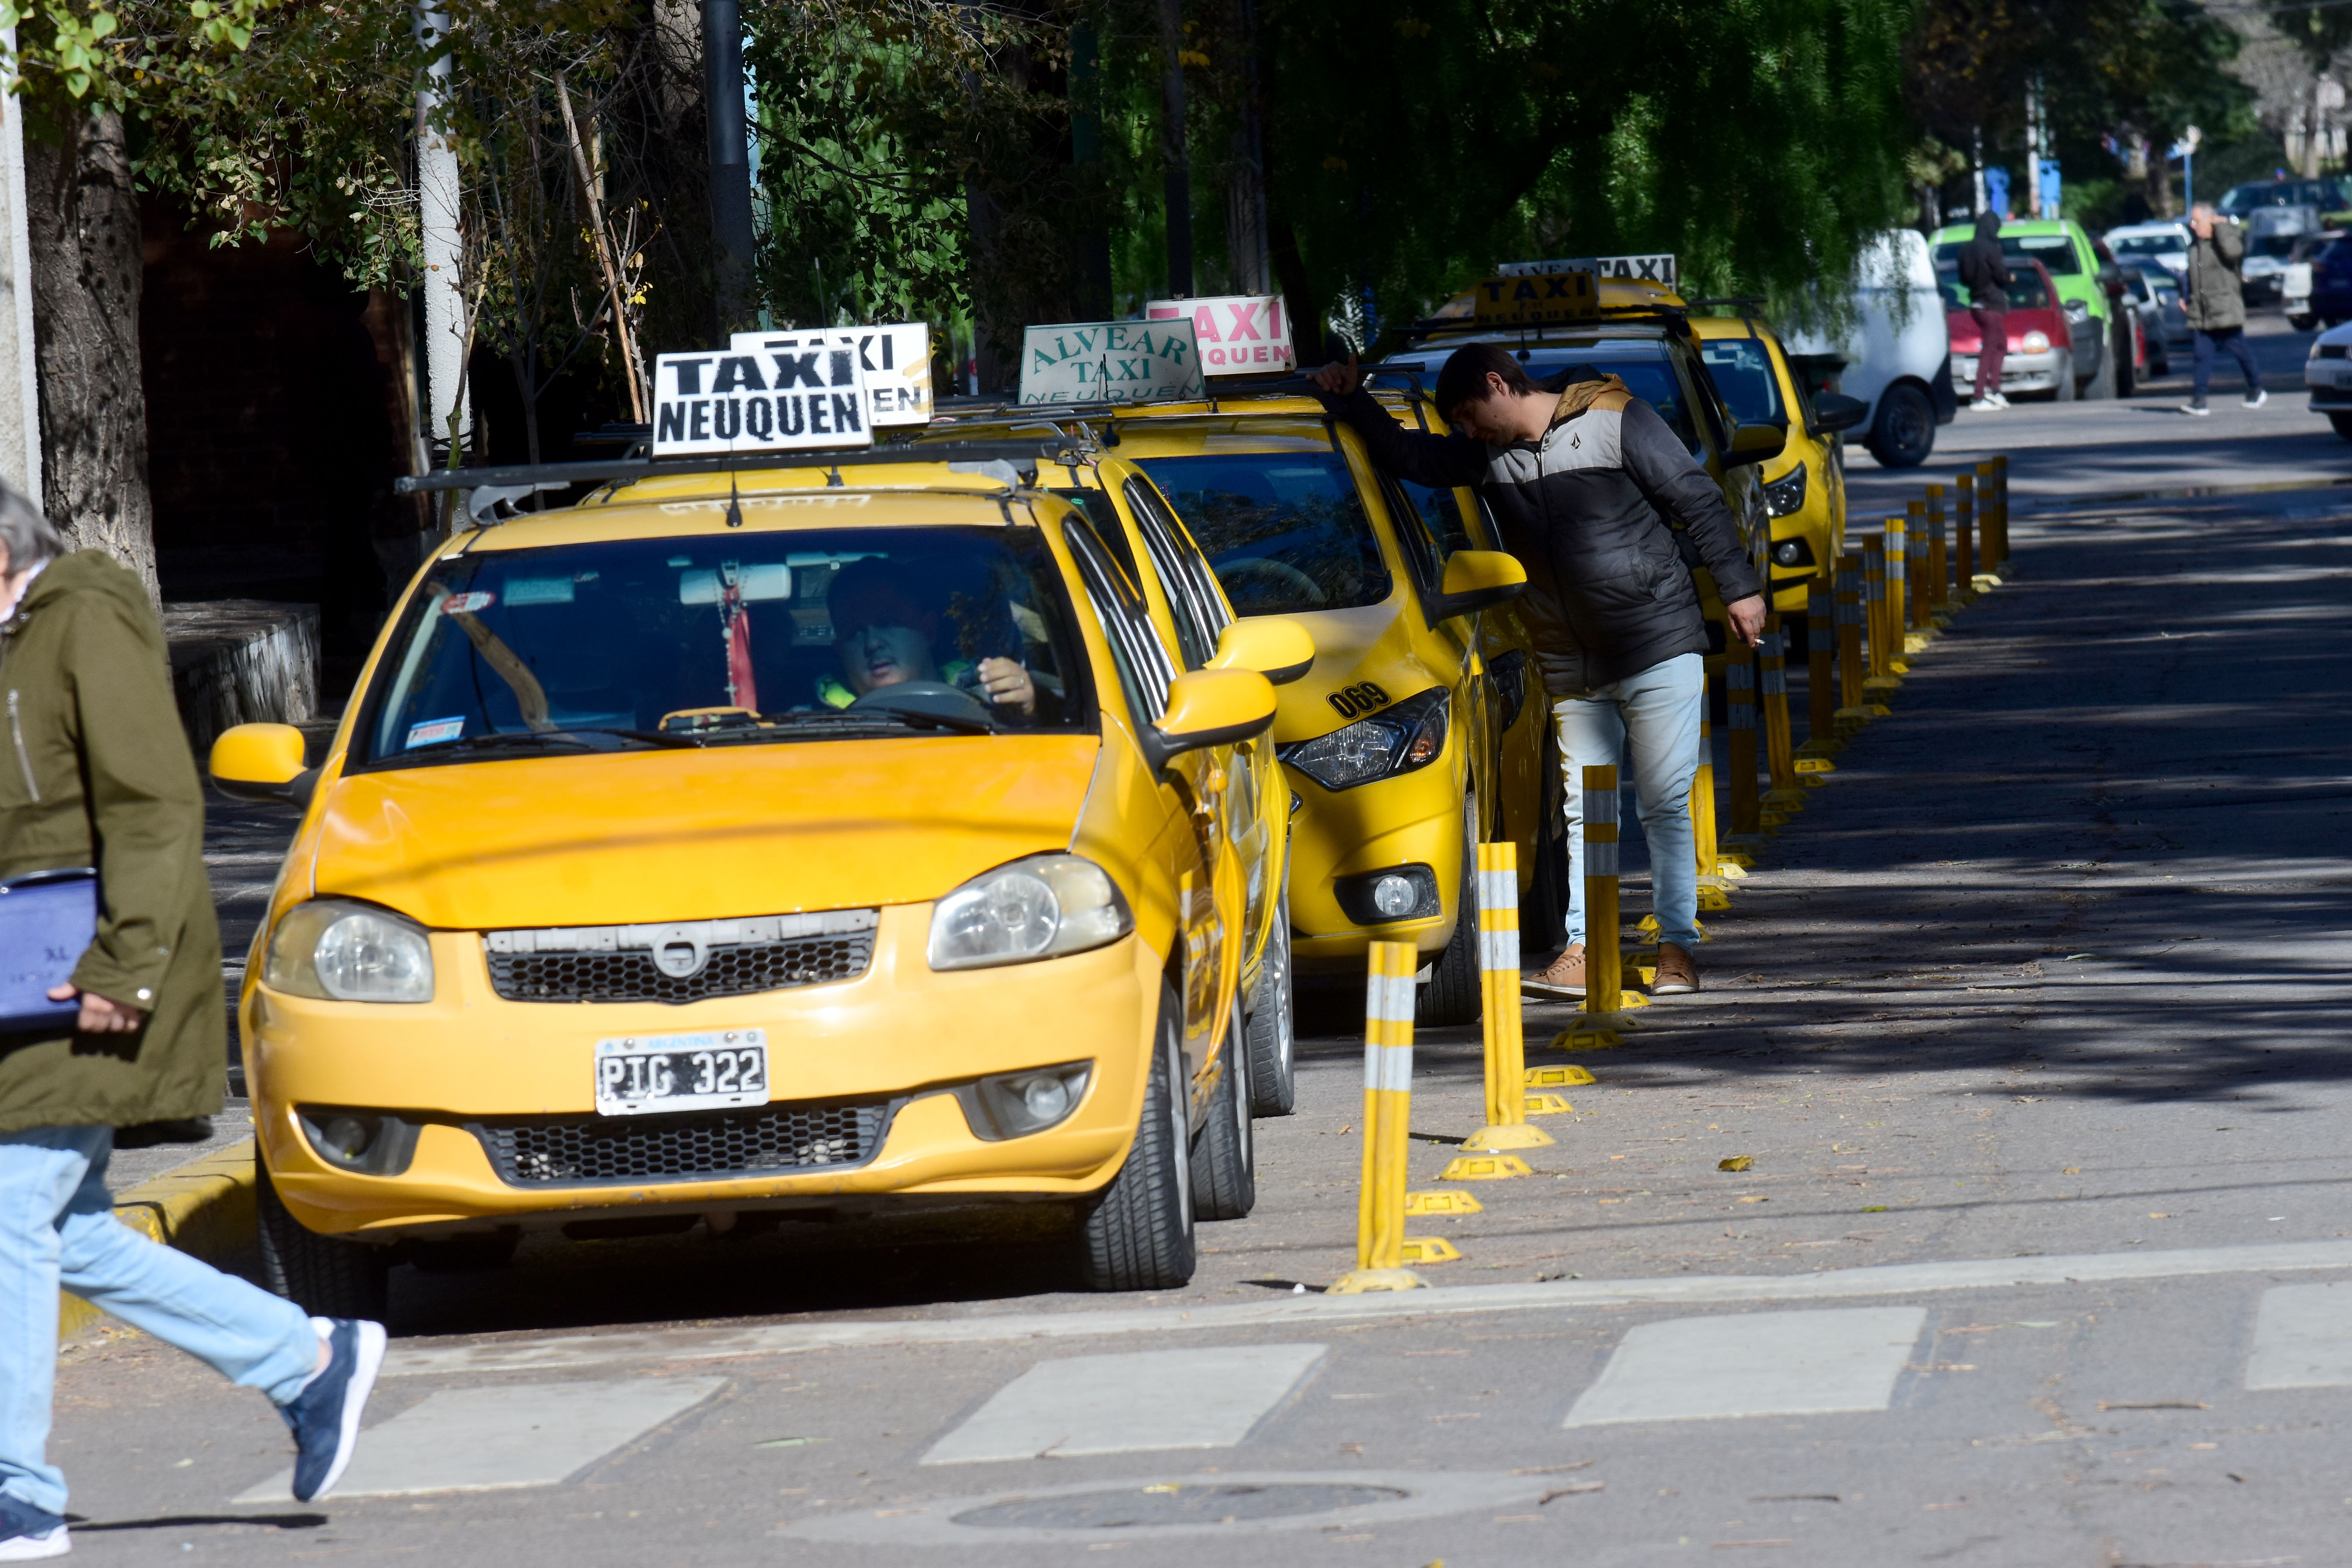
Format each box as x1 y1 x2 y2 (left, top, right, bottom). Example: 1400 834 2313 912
1691 301 1870 625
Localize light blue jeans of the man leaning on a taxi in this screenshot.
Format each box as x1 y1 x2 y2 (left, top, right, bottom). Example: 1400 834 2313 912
1552 654 1707 952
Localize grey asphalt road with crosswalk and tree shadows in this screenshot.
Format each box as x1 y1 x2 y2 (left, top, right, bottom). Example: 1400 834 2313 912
54 409 2352 1568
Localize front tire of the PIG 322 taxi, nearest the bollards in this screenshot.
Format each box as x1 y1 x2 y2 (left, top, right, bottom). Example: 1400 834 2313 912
1079 980 1197 1291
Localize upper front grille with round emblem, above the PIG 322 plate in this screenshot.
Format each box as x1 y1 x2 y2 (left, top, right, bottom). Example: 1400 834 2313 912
482 910 877 1004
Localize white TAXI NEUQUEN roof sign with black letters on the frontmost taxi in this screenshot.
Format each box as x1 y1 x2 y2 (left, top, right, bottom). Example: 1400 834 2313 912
654 346 875 459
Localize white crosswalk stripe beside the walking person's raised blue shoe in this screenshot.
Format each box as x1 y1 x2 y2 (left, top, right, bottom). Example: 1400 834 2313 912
238 1378 727 1502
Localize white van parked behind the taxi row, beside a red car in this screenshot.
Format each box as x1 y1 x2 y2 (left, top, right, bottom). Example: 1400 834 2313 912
1783 228 1959 468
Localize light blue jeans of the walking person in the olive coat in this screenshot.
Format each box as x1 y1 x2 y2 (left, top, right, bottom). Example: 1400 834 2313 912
0 1126 318 1514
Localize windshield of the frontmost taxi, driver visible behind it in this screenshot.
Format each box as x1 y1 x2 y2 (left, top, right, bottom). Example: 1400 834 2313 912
355 527 1091 767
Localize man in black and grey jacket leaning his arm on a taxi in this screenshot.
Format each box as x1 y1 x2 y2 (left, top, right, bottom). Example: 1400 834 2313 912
1312 343 1764 997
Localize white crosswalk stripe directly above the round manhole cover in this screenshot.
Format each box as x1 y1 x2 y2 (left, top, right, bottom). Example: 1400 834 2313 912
922 1345 1327 1464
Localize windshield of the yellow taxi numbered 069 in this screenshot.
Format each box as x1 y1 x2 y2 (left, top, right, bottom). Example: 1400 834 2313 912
1136 451 1390 616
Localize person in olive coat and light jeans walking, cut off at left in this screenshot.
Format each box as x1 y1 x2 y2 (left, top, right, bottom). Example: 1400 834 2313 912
0 487 384 1563
